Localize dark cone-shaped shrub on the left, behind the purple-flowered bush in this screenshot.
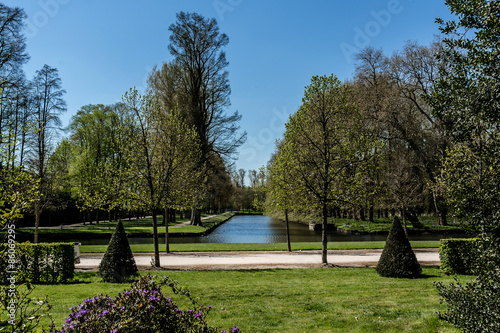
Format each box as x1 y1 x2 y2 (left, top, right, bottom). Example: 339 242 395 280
99 221 137 283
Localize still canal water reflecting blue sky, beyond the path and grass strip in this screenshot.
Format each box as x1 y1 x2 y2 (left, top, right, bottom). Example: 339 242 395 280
89 215 460 244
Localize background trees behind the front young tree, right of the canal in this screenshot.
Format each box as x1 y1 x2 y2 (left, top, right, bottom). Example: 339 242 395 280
269 38 449 227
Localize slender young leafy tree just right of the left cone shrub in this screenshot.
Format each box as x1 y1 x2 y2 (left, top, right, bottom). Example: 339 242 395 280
123 89 204 267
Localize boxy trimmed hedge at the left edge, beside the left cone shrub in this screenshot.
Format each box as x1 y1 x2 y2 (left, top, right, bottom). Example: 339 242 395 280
0 242 75 284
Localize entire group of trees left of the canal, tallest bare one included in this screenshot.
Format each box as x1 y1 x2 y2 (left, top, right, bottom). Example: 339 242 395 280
0 4 253 266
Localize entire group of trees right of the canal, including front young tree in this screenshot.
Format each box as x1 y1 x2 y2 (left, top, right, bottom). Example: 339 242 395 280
266 42 450 262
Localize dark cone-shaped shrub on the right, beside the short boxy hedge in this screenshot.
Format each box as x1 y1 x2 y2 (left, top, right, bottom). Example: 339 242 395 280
377 217 422 278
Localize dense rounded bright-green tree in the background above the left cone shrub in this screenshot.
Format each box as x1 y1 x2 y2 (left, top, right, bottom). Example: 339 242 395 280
67 105 128 221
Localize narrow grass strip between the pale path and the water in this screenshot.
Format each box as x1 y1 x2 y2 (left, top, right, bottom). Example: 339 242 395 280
80 241 439 253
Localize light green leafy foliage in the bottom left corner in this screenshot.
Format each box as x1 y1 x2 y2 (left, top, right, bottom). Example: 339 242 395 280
0 282 52 333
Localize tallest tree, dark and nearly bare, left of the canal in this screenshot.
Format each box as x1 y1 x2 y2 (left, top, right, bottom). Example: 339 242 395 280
151 12 246 224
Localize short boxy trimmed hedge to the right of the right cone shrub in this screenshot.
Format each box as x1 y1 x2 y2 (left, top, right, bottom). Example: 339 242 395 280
439 238 479 275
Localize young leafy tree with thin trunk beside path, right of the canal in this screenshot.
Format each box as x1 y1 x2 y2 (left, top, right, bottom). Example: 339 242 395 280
275 75 375 264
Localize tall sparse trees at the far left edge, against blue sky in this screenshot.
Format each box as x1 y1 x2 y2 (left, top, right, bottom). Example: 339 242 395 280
0 4 66 242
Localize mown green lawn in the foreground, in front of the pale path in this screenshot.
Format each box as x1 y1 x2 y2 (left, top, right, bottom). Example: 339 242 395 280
31 267 471 333
